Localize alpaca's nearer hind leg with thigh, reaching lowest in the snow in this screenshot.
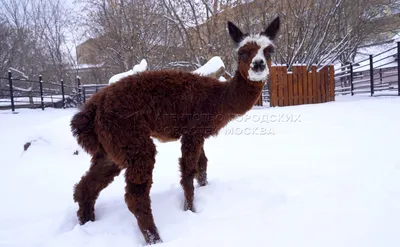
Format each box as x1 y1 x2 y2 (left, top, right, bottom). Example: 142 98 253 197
99 118 162 244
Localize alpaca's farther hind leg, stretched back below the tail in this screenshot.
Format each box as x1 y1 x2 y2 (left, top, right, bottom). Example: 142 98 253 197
74 153 121 225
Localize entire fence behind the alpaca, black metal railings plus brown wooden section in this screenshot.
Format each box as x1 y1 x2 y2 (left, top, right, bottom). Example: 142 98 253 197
5 42 400 112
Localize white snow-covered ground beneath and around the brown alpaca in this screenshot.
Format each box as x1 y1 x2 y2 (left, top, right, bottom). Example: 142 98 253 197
0 96 400 247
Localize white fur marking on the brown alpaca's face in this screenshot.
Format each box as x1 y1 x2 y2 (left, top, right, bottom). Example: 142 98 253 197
237 34 274 82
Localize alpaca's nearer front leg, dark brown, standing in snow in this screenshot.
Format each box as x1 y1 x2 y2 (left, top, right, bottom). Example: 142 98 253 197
179 136 204 212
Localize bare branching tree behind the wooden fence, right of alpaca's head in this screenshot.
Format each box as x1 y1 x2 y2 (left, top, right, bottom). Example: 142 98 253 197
262 0 400 67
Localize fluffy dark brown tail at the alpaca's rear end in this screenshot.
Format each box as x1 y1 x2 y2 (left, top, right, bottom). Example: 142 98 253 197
70 105 100 155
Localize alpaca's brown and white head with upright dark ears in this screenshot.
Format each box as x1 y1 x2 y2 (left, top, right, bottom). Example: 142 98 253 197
228 16 280 83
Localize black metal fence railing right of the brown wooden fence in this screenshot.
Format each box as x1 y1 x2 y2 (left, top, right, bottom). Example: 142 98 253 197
335 42 400 96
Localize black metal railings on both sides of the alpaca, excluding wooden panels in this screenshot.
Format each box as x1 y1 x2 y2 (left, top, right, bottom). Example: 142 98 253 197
0 42 400 112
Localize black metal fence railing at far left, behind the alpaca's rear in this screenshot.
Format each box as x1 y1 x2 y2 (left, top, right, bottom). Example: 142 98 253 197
0 71 80 112
